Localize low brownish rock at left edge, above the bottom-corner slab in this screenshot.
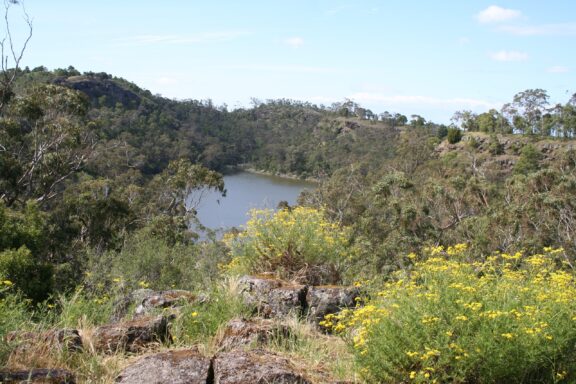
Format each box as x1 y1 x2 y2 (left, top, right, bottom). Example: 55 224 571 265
5 328 82 354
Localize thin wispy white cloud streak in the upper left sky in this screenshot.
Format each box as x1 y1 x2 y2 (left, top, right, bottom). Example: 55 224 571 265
117 31 250 45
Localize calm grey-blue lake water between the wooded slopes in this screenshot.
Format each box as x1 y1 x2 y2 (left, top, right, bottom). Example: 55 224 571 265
198 172 316 229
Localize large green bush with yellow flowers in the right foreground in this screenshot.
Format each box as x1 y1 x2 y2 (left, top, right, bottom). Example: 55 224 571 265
324 244 576 384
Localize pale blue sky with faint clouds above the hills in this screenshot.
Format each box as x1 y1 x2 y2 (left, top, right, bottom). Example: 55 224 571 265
5 0 576 123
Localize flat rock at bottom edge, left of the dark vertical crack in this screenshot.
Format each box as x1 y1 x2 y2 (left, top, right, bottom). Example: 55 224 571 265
116 350 210 384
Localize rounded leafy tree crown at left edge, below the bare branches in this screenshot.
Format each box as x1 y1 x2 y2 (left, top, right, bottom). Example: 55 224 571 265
0 85 96 206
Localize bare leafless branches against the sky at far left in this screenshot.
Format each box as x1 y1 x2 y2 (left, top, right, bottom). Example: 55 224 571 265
0 0 32 114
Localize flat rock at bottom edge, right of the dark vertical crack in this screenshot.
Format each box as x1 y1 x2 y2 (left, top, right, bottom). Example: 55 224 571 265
213 350 311 384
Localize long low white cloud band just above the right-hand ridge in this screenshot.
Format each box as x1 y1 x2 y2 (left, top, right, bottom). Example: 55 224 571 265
350 92 498 109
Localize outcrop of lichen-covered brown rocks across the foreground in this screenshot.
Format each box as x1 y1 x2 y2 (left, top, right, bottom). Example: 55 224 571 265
0 276 360 384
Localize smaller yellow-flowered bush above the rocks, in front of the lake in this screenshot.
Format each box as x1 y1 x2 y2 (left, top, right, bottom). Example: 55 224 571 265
224 207 349 284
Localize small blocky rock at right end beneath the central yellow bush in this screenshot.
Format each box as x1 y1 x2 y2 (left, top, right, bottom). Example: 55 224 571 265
306 286 360 324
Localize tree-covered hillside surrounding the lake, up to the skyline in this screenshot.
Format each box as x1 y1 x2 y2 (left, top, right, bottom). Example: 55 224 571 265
1 67 576 293
